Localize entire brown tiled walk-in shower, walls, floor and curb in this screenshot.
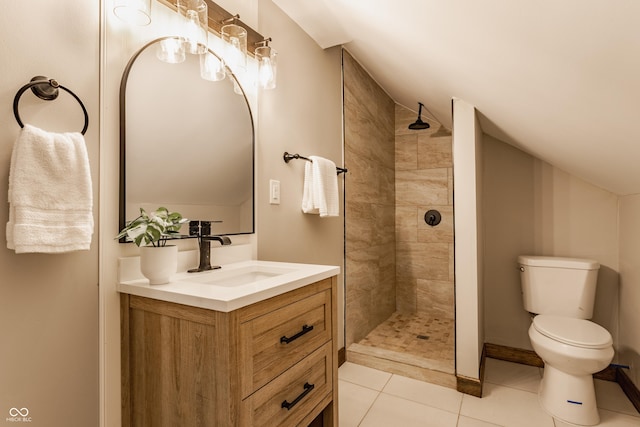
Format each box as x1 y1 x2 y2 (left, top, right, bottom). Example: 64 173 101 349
343 51 455 387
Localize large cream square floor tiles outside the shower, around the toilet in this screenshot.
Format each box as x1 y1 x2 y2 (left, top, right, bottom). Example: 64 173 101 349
339 359 640 427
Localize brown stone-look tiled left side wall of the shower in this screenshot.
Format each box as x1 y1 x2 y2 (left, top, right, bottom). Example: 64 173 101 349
343 51 396 346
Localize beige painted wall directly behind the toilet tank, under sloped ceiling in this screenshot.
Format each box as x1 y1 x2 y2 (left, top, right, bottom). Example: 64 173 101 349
483 135 618 348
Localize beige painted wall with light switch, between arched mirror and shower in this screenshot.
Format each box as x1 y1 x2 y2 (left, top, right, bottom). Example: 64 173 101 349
256 0 344 347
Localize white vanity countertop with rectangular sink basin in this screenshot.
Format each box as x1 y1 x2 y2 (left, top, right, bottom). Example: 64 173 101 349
117 260 340 312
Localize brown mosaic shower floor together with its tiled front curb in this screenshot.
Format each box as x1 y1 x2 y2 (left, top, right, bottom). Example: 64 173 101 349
347 312 455 387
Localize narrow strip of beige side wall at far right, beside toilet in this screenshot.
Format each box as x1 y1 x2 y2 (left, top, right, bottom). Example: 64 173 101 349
617 194 640 388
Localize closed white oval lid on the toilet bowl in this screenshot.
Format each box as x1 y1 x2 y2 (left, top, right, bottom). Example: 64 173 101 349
533 314 613 348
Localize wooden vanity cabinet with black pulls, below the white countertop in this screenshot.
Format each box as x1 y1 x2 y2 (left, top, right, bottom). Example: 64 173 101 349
120 277 338 427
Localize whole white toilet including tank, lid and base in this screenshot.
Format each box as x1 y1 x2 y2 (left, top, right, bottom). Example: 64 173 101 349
518 256 614 425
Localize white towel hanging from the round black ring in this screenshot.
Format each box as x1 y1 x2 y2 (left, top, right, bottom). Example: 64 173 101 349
7 125 93 253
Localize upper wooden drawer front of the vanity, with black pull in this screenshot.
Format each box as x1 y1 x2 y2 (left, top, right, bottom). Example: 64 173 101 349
239 288 332 398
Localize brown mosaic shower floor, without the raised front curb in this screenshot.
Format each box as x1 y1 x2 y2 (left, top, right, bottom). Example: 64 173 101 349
358 312 455 367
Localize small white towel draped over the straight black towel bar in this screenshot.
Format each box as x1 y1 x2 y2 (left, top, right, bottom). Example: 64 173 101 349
302 156 339 217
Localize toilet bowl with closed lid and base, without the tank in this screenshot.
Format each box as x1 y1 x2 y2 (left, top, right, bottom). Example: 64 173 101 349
529 314 614 425
